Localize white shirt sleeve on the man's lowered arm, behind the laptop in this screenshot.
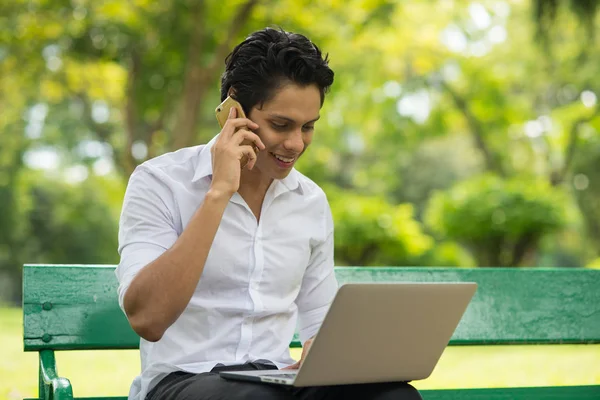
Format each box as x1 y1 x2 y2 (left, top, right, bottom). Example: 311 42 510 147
296 200 338 343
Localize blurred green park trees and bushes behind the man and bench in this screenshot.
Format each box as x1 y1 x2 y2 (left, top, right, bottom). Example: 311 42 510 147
0 0 600 304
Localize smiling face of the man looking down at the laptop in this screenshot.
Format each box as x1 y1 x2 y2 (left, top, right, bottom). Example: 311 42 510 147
248 83 321 179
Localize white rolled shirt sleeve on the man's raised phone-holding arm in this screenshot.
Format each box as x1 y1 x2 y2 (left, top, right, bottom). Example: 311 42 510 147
115 167 179 312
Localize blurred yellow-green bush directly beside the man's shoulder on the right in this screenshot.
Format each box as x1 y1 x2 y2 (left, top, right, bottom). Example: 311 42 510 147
330 192 433 266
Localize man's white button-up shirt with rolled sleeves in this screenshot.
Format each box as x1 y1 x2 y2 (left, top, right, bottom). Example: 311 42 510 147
116 139 337 400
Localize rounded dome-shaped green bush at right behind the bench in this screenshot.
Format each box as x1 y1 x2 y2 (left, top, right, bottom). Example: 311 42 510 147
426 175 566 266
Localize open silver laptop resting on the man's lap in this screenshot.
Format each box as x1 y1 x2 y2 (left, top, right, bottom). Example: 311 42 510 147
220 282 477 387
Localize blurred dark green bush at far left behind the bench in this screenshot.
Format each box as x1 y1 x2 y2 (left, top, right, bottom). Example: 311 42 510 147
0 172 124 302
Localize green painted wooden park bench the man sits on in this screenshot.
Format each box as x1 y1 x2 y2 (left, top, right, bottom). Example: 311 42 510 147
23 265 600 400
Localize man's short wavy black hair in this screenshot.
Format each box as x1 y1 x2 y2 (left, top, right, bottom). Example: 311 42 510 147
221 28 334 115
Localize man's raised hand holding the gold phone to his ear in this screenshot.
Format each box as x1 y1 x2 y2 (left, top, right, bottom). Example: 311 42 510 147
211 107 265 197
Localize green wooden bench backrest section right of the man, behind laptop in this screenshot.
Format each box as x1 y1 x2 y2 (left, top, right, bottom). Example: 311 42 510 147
336 268 600 345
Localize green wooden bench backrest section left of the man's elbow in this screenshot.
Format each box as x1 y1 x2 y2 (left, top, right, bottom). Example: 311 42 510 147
23 266 139 351
